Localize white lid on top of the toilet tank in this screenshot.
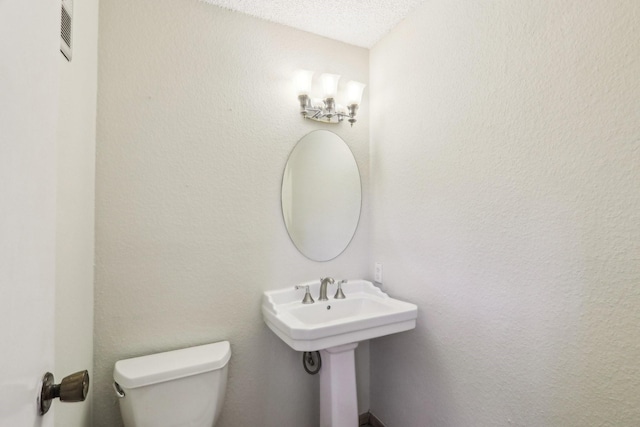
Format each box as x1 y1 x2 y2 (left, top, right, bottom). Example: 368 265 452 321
113 341 231 389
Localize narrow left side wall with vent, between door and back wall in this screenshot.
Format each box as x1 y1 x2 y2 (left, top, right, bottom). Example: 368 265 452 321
54 0 98 427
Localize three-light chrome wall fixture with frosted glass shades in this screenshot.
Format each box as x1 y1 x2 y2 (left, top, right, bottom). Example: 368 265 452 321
294 70 366 126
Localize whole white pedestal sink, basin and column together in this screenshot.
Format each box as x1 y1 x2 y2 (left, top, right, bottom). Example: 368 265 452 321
262 280 418 427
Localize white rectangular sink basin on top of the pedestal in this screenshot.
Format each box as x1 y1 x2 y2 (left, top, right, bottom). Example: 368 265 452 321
262 280 418 351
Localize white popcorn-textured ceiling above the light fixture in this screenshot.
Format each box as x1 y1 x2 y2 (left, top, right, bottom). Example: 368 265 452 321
203 0 423 48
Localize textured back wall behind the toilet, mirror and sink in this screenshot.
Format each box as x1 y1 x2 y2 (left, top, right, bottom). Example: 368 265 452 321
93 0 369 427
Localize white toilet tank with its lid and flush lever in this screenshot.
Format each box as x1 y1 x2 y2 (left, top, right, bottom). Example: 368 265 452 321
113 341 231 427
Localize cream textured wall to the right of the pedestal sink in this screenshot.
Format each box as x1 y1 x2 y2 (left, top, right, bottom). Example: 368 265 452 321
370 0 640 427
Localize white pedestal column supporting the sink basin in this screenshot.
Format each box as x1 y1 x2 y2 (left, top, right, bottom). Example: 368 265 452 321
320 342 358 427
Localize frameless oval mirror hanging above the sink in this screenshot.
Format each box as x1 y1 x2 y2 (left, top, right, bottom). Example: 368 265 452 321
282 130 362 261
